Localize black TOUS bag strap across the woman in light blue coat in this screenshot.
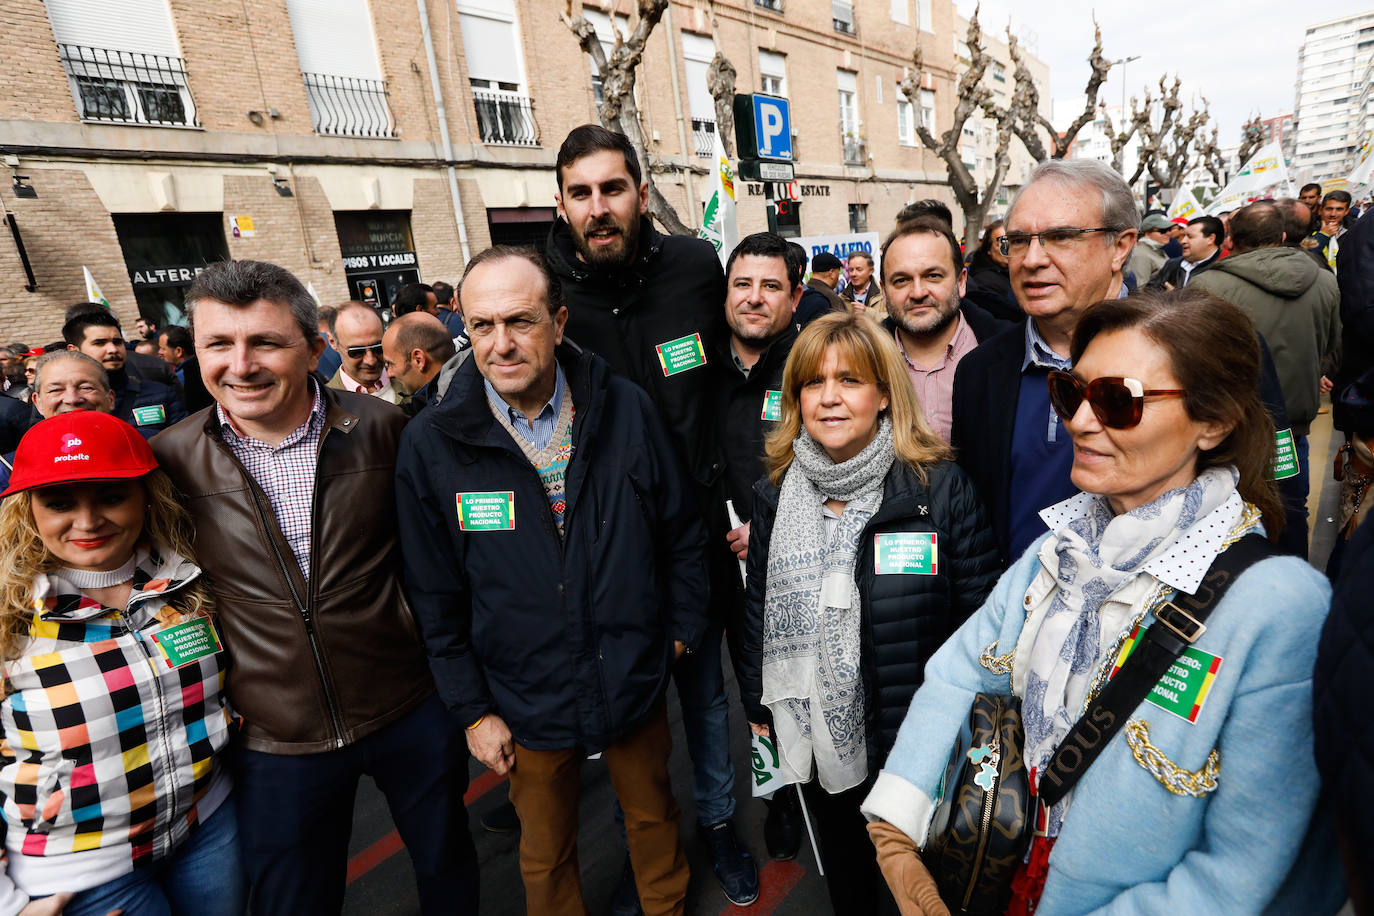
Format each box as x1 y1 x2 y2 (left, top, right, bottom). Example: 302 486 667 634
1037 533 1278 805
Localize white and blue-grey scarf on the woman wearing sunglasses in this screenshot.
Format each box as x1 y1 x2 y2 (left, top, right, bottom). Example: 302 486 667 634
1021 467 1242 836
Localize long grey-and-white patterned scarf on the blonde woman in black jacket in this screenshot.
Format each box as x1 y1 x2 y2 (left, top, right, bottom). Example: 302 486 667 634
763 416 896 794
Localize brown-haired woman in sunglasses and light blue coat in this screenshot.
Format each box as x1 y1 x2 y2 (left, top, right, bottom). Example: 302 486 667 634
864 290 1344 916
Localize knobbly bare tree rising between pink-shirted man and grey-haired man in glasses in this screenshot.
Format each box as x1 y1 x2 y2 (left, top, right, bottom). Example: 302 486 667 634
900 7 1014 240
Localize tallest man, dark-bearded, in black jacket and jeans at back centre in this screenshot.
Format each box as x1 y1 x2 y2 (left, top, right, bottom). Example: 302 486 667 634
541 125 757 904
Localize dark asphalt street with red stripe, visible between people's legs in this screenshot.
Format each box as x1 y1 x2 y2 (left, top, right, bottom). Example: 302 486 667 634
344 398 1342 916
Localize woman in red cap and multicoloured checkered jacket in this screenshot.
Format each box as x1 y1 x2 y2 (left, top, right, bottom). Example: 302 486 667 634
0 411 246 916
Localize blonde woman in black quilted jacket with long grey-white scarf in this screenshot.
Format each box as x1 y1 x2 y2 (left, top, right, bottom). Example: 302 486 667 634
739 313 998 916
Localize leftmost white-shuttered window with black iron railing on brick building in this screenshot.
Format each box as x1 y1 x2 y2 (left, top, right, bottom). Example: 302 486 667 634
44 0 199 126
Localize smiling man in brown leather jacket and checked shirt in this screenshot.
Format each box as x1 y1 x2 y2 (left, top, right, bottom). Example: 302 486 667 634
153 261 477 916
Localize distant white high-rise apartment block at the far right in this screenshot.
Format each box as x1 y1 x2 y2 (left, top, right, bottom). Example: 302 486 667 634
1292 11 1374 183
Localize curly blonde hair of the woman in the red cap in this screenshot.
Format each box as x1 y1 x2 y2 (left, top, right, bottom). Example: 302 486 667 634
0 470 213 662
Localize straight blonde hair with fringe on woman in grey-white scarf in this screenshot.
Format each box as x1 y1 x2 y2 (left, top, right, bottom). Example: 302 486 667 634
764 312 952 486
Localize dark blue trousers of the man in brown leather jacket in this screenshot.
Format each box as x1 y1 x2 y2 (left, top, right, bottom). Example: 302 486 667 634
236 695 478 916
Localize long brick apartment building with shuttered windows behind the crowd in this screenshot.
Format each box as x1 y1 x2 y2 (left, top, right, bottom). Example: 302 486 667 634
0 0 1000 336
